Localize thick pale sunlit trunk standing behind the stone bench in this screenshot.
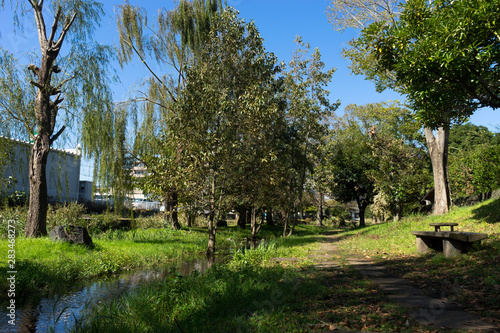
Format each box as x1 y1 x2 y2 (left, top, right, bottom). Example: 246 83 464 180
424 127 451 215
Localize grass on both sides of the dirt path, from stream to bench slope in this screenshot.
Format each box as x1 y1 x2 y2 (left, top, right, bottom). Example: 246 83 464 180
74 200 500 332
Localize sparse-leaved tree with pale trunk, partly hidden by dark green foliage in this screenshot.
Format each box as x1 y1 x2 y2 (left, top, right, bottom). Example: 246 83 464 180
328 0 458 214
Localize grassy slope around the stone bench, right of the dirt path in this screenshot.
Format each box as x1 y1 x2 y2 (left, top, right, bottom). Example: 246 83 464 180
339 199 500 325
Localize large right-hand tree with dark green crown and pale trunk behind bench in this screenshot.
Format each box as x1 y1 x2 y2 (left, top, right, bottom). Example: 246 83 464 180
329 0 500 214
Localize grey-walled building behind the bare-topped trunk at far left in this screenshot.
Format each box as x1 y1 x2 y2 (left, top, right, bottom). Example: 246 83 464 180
0 137 81 202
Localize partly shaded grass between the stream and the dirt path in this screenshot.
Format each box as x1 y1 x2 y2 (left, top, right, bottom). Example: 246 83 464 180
74 237 415 332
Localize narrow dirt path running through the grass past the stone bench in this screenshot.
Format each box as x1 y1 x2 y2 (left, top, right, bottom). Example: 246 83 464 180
287 235 500 332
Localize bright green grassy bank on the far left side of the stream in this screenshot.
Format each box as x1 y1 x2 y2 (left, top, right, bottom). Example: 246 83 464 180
0 217 318 301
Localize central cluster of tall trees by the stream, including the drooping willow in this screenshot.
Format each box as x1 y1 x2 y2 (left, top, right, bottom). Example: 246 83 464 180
118 1 338 253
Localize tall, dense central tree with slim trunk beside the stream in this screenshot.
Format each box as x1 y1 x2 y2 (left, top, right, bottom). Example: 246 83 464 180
176 9 280 254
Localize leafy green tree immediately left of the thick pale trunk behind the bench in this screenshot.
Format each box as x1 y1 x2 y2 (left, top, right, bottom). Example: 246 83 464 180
358 103 430 220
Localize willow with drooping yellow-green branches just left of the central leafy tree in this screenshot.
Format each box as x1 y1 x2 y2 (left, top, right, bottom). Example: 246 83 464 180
117 0 222 229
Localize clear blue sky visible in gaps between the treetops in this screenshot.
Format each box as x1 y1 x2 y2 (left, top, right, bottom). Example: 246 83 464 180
0 0 500 176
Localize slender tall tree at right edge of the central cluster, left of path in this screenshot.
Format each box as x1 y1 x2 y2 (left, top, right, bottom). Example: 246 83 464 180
283 36 339 236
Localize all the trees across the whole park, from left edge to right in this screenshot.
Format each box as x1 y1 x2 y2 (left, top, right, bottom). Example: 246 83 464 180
0 0 500 253
